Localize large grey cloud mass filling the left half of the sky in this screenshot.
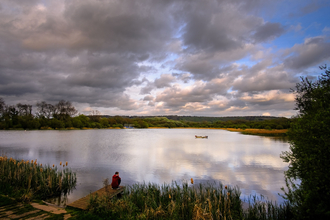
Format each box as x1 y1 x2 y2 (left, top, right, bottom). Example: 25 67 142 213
0 1 180 110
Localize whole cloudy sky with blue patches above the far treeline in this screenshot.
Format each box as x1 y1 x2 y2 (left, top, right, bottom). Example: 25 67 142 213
0 0 330 118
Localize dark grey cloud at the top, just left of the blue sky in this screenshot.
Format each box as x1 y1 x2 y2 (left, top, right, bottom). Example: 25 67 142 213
179 1 262 52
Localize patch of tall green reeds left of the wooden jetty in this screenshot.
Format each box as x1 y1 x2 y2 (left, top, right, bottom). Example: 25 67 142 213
0 156 77 200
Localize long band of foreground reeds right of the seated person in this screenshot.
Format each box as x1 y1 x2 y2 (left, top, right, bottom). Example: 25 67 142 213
89 181 291 220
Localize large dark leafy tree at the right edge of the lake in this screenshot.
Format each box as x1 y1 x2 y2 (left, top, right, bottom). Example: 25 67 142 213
281 66 330 219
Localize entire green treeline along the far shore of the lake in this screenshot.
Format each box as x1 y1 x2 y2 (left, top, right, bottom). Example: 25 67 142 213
0 98 291 130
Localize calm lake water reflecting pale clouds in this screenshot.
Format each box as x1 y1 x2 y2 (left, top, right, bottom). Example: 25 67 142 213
0 129 289 203
